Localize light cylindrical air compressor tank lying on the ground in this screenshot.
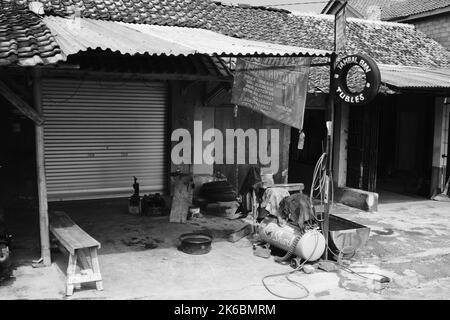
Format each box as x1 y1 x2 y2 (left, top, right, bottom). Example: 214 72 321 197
259 217 325 261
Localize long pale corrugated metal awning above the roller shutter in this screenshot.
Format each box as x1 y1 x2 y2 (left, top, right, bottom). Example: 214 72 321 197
43 16 331 56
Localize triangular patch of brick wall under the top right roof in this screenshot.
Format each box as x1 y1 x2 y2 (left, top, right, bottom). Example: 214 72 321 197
408 12 450 50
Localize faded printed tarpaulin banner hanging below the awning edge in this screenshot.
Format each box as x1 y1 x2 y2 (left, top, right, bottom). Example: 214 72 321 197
231 57 311 130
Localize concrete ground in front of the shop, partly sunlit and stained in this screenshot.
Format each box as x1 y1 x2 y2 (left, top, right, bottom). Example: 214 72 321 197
0 198 450 299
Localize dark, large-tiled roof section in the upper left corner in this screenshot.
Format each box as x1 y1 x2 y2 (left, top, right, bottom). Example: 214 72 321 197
0 6 64 66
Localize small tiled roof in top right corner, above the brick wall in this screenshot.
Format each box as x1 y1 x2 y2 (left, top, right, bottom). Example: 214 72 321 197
382 0 450 20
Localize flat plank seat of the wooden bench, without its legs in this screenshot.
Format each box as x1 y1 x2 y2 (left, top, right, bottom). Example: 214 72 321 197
50 211 101 254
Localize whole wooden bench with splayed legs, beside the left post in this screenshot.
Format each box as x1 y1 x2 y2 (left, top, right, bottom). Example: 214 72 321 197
49 211 103 296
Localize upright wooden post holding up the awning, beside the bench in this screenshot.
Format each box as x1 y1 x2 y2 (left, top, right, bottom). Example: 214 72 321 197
33 69 51 266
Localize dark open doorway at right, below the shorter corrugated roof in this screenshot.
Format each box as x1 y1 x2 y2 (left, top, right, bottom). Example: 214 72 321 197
377 95 434 199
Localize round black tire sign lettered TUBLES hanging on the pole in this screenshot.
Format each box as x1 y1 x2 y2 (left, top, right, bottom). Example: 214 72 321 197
334 54 381 106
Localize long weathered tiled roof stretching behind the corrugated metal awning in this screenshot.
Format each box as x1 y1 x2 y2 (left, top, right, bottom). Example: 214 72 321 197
0 0 450 71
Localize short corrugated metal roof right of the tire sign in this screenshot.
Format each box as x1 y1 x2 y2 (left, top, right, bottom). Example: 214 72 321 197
378 64 450 89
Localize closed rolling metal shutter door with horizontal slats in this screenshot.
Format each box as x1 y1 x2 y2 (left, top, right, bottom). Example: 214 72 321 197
42 79 168 201
